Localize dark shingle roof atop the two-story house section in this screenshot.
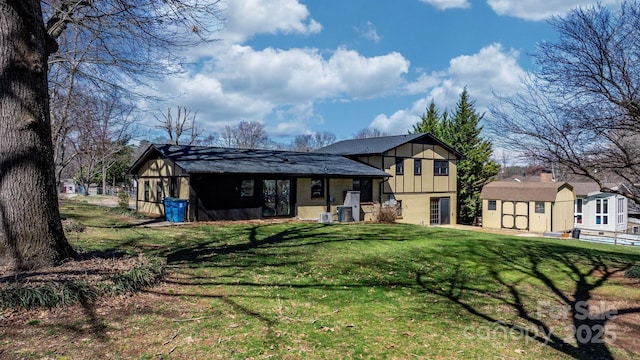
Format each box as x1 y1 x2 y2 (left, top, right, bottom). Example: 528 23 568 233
316 133 462 158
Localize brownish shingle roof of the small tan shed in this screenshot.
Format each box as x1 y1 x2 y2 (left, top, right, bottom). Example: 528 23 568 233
480 181 573 202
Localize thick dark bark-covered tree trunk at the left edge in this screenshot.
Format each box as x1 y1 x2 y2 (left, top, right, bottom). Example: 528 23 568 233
0 0 75 269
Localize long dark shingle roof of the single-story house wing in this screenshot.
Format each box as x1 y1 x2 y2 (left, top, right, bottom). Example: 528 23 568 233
129 144 389 177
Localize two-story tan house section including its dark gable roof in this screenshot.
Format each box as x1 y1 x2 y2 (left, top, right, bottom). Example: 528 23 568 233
317 133 462 225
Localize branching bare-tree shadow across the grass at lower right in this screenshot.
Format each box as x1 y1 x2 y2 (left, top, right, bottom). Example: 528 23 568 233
416 239 640 359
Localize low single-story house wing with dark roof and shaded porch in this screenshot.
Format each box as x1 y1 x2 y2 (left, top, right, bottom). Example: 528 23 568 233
129 145 388 221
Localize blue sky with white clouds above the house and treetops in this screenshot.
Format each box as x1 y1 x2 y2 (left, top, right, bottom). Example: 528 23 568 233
142 0 620 143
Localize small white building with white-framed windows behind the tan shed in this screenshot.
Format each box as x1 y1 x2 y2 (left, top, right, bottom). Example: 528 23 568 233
571 182 629 232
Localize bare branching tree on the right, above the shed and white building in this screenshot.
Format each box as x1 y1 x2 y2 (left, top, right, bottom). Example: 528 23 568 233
490 1 640 203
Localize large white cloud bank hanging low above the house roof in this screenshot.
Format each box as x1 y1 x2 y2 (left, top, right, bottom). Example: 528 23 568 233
161 45 409 135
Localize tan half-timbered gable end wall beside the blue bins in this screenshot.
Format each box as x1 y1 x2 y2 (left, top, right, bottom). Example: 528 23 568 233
137 158 189 215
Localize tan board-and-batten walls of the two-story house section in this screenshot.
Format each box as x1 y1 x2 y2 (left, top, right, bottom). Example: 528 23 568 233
357 143 457 225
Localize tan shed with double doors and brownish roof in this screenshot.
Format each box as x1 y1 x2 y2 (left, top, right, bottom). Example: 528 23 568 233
480 180 575 233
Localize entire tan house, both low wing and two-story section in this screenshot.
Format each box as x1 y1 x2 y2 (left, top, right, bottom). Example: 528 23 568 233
129 138 461 225
